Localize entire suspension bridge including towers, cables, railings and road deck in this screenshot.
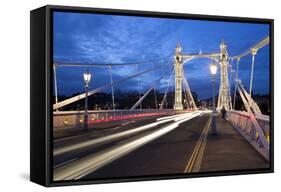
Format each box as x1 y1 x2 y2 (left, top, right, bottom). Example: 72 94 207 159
53 37 270 180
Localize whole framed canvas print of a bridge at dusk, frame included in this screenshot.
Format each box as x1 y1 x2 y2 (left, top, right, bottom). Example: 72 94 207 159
30 5 274 186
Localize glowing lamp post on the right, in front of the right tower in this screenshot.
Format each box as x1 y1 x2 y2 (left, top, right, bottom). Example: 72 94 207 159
210 63 218 135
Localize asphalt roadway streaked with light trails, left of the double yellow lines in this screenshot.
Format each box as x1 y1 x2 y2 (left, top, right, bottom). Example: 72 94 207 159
54 112 209 180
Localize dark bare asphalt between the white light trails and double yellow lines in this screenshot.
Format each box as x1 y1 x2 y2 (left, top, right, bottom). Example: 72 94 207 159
83 114 209 179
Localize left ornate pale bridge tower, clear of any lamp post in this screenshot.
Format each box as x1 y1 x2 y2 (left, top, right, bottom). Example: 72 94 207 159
174 43 183 110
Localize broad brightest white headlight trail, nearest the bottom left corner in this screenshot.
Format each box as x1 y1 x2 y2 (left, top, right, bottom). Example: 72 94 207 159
54 112 201 181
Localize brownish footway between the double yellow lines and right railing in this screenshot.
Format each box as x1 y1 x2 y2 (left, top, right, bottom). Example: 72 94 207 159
200 116 269 172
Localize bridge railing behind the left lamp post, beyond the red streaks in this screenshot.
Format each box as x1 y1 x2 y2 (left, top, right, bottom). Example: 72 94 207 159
53 109 173 129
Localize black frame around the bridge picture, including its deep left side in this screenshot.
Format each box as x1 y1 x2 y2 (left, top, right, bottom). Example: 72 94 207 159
30 5 274 186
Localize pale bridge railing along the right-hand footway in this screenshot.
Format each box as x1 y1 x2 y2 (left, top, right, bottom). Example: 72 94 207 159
228 110 270 160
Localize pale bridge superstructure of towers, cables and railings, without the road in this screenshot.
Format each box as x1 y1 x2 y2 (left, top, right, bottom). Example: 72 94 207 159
53 37 270 158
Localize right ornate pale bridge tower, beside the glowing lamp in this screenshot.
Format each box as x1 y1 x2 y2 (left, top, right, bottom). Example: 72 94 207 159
217 41 231 110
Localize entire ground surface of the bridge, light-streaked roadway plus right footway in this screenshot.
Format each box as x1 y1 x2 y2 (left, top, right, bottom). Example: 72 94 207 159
53 111 269 180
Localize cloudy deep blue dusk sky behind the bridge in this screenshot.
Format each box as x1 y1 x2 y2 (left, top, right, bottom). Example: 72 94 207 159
53 12 270 99
